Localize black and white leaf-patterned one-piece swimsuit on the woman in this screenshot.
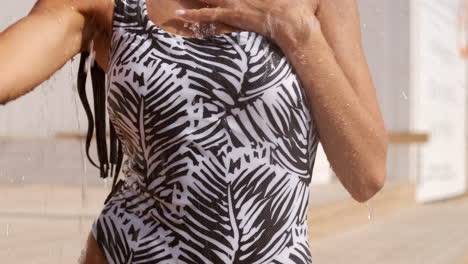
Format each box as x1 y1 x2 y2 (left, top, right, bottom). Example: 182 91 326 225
93 0 318 264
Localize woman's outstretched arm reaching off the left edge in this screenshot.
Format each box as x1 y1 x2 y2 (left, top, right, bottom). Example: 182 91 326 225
0 0 104 104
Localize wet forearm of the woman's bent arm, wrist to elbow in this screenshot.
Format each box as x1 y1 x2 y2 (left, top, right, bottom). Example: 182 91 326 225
280 28 387 201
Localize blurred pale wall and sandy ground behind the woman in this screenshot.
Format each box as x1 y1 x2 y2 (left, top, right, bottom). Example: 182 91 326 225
0 0 468 264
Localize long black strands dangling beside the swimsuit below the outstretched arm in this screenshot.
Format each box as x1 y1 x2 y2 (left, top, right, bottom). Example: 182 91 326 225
77 51 123 204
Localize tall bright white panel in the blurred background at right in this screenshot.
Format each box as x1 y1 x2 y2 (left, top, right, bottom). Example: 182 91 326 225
411 0 468 202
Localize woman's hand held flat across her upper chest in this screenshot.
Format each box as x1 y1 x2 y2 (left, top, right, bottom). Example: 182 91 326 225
176 0 320 45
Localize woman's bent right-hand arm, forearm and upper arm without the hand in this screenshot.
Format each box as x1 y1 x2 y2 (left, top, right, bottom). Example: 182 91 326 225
281 0 388 202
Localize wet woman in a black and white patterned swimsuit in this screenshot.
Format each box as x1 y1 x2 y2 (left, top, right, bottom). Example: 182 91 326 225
0 0 387 264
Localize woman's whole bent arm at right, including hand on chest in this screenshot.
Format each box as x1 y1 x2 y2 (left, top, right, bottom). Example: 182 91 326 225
172 0 388 202
